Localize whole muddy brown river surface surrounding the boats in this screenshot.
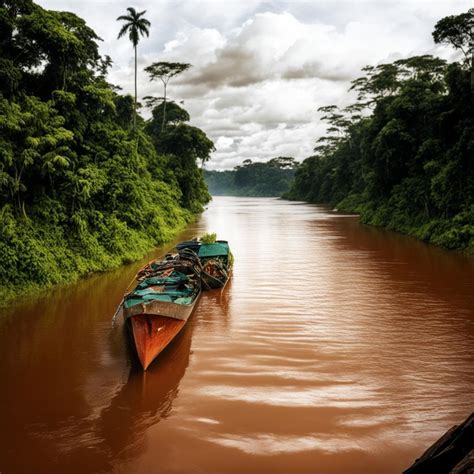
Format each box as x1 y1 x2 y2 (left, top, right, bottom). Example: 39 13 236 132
0 197 474 474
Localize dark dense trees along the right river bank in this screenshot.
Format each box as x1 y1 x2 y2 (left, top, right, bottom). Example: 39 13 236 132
285 10 474 252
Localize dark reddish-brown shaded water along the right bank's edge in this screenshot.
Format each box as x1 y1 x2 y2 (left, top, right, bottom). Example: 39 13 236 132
307 211 474 308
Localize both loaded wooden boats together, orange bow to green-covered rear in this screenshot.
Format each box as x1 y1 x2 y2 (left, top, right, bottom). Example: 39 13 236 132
114 240 233 370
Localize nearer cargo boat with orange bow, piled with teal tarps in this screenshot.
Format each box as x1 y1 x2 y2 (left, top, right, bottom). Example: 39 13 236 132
123 252 201 370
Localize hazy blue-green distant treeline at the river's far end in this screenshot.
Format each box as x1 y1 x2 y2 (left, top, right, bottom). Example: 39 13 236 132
204 157 297 197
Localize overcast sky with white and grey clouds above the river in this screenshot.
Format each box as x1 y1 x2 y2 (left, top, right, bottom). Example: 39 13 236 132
38 0 471 169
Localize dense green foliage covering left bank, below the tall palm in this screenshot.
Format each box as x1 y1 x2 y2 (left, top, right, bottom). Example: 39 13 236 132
0 0 213 302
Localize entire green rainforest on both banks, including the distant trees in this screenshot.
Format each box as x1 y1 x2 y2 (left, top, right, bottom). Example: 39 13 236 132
0 0 474 302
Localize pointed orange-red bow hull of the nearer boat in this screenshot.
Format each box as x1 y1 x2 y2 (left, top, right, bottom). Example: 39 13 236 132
129 314 186 370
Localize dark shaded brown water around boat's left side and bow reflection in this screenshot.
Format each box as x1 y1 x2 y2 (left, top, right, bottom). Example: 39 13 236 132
0 225 208 473
